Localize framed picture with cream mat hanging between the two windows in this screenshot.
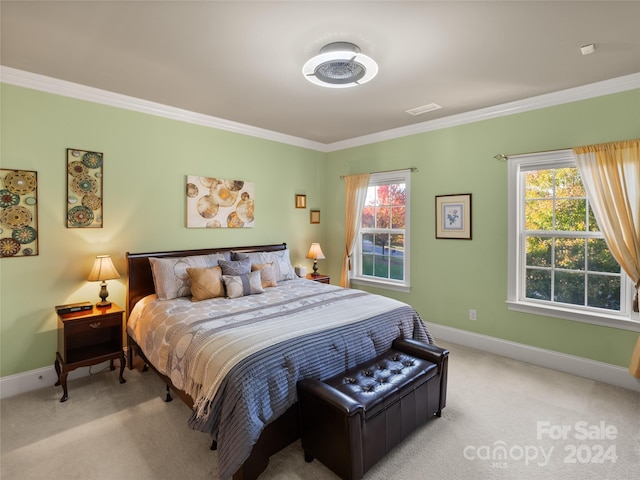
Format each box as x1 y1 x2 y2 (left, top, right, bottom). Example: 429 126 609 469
436 193 471 240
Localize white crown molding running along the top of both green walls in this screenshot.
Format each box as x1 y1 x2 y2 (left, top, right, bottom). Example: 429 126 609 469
0 66 640 152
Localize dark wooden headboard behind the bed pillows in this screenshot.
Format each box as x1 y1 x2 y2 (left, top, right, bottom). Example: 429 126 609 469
127 243 287 317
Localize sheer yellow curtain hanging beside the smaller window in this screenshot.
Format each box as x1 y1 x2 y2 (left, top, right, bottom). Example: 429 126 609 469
340 173 369 288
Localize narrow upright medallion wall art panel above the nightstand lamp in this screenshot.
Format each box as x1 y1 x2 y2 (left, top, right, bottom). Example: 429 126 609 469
67 148 103 228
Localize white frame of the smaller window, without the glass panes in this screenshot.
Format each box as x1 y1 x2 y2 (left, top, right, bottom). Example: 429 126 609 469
349 170 411 292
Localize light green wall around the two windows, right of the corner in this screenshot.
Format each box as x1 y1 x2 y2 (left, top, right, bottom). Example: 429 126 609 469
323 90 640 367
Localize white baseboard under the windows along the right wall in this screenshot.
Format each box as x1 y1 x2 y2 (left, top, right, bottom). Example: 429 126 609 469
429 323 640 392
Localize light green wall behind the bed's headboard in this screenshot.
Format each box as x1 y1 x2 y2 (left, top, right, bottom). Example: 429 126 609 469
0 84 326 376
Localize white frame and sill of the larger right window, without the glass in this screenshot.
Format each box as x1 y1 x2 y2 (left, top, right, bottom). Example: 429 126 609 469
507 149 640 332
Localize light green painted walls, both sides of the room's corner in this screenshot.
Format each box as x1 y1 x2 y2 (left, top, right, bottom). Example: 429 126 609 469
0 84 640 376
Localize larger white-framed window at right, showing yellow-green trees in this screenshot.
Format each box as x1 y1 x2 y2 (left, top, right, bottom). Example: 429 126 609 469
508 150 636 329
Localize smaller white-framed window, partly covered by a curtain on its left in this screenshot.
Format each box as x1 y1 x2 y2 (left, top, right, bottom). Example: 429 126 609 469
352 170 410 291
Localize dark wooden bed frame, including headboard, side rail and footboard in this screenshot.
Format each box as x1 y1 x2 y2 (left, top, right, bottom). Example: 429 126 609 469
127 243 300 480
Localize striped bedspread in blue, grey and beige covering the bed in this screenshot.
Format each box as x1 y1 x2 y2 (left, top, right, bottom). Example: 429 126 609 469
128 280 433 480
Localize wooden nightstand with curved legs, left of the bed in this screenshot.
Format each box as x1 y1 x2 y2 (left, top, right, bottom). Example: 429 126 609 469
55 303 126 402
